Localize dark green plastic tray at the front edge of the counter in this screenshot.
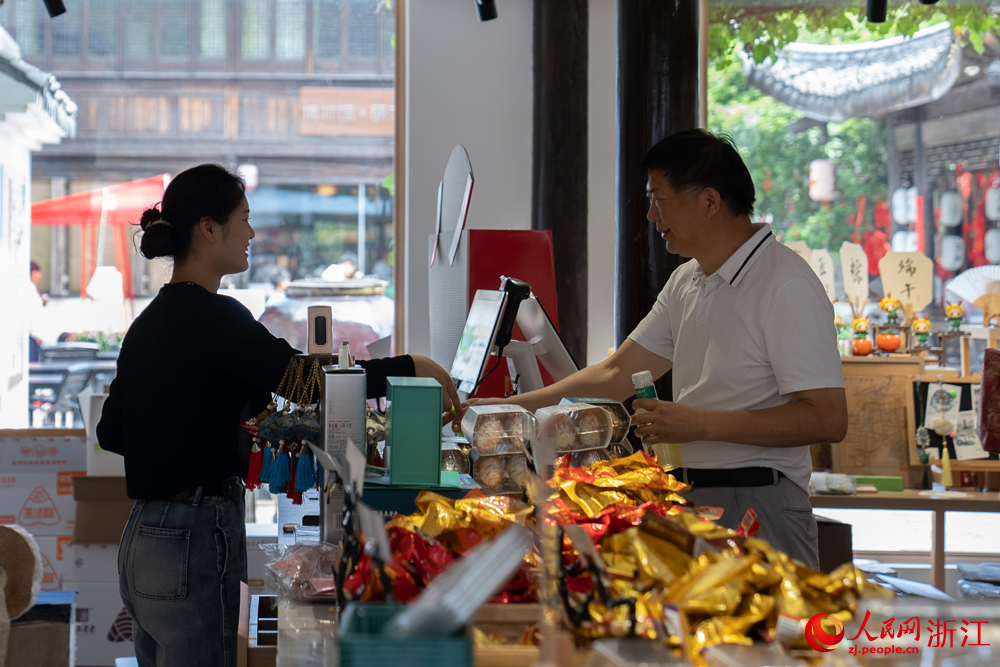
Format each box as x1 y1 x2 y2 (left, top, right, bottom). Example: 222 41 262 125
338 602 472 667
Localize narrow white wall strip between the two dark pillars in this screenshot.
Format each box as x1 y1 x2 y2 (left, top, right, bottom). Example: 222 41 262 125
587 0 618 364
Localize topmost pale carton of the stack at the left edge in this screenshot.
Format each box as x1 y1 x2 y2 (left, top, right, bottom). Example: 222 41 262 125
0 429 87 476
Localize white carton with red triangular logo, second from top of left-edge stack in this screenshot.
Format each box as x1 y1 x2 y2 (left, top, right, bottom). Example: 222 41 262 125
0 471 84 537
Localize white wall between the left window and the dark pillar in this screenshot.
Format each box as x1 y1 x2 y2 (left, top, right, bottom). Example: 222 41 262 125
404 0 533 354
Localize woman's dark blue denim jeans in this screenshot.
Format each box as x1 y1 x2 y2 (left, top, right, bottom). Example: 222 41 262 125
118 489 247 667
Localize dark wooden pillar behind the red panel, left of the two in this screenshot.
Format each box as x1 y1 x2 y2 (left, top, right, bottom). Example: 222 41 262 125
531 0 590 366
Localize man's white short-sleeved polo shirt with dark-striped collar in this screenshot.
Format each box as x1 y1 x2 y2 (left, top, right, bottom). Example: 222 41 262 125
629 225 844 491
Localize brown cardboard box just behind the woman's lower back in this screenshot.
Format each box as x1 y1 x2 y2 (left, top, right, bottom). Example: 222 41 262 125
72 477 135 544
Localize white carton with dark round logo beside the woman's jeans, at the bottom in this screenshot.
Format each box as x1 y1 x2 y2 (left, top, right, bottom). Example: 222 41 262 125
66 577 135 667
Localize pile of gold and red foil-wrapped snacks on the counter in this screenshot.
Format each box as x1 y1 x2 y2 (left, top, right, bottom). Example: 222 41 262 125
345 446 892 664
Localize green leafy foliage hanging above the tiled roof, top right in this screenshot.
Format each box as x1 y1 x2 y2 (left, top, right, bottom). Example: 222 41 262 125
709 0 1000 68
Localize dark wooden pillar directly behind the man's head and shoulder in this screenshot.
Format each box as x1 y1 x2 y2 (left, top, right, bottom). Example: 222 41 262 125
615 0 699 398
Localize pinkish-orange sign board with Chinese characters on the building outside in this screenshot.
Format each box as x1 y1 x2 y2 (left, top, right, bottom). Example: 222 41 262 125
299 87 396 137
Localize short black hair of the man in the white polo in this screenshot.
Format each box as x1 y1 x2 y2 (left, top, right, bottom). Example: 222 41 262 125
640 130 756 220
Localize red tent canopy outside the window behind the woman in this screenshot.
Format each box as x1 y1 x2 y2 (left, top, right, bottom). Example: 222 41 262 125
31 174 170 226
